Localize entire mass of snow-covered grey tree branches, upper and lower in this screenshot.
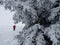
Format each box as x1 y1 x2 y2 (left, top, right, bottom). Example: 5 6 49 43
0 0 60 45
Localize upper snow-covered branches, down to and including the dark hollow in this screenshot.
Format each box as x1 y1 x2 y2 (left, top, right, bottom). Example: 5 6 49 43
0 0 60 26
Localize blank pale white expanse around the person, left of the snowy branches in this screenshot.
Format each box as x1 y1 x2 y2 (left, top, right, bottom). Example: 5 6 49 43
0 6 24 45
